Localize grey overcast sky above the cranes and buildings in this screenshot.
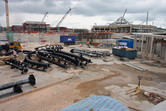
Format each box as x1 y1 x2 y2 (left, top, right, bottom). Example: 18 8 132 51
0 0 166 29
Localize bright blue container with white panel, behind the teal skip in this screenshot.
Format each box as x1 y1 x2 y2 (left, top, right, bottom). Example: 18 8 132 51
119 40 134 48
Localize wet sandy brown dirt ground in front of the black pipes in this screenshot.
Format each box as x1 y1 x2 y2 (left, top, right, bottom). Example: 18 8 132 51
0 44 166 111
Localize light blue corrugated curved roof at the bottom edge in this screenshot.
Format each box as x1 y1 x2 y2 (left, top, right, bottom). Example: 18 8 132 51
59 96 129 111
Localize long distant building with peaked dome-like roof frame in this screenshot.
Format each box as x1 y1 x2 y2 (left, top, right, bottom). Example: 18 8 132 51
92 17 157 33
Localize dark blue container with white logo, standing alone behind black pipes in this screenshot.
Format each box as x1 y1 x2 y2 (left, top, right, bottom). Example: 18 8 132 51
60 36 75 43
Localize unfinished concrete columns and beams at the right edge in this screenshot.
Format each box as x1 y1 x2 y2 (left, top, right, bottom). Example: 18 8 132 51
134 34 166 62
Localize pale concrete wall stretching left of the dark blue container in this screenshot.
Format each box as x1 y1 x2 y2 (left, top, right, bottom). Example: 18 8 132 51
0 33 60 42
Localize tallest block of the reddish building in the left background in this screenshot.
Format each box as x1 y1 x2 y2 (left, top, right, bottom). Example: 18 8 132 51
23 21 50 32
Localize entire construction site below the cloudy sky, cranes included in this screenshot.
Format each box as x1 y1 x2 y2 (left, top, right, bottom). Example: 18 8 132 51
0 0 166 111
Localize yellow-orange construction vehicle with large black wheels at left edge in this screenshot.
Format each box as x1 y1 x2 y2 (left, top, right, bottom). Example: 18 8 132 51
0 40 22 55
